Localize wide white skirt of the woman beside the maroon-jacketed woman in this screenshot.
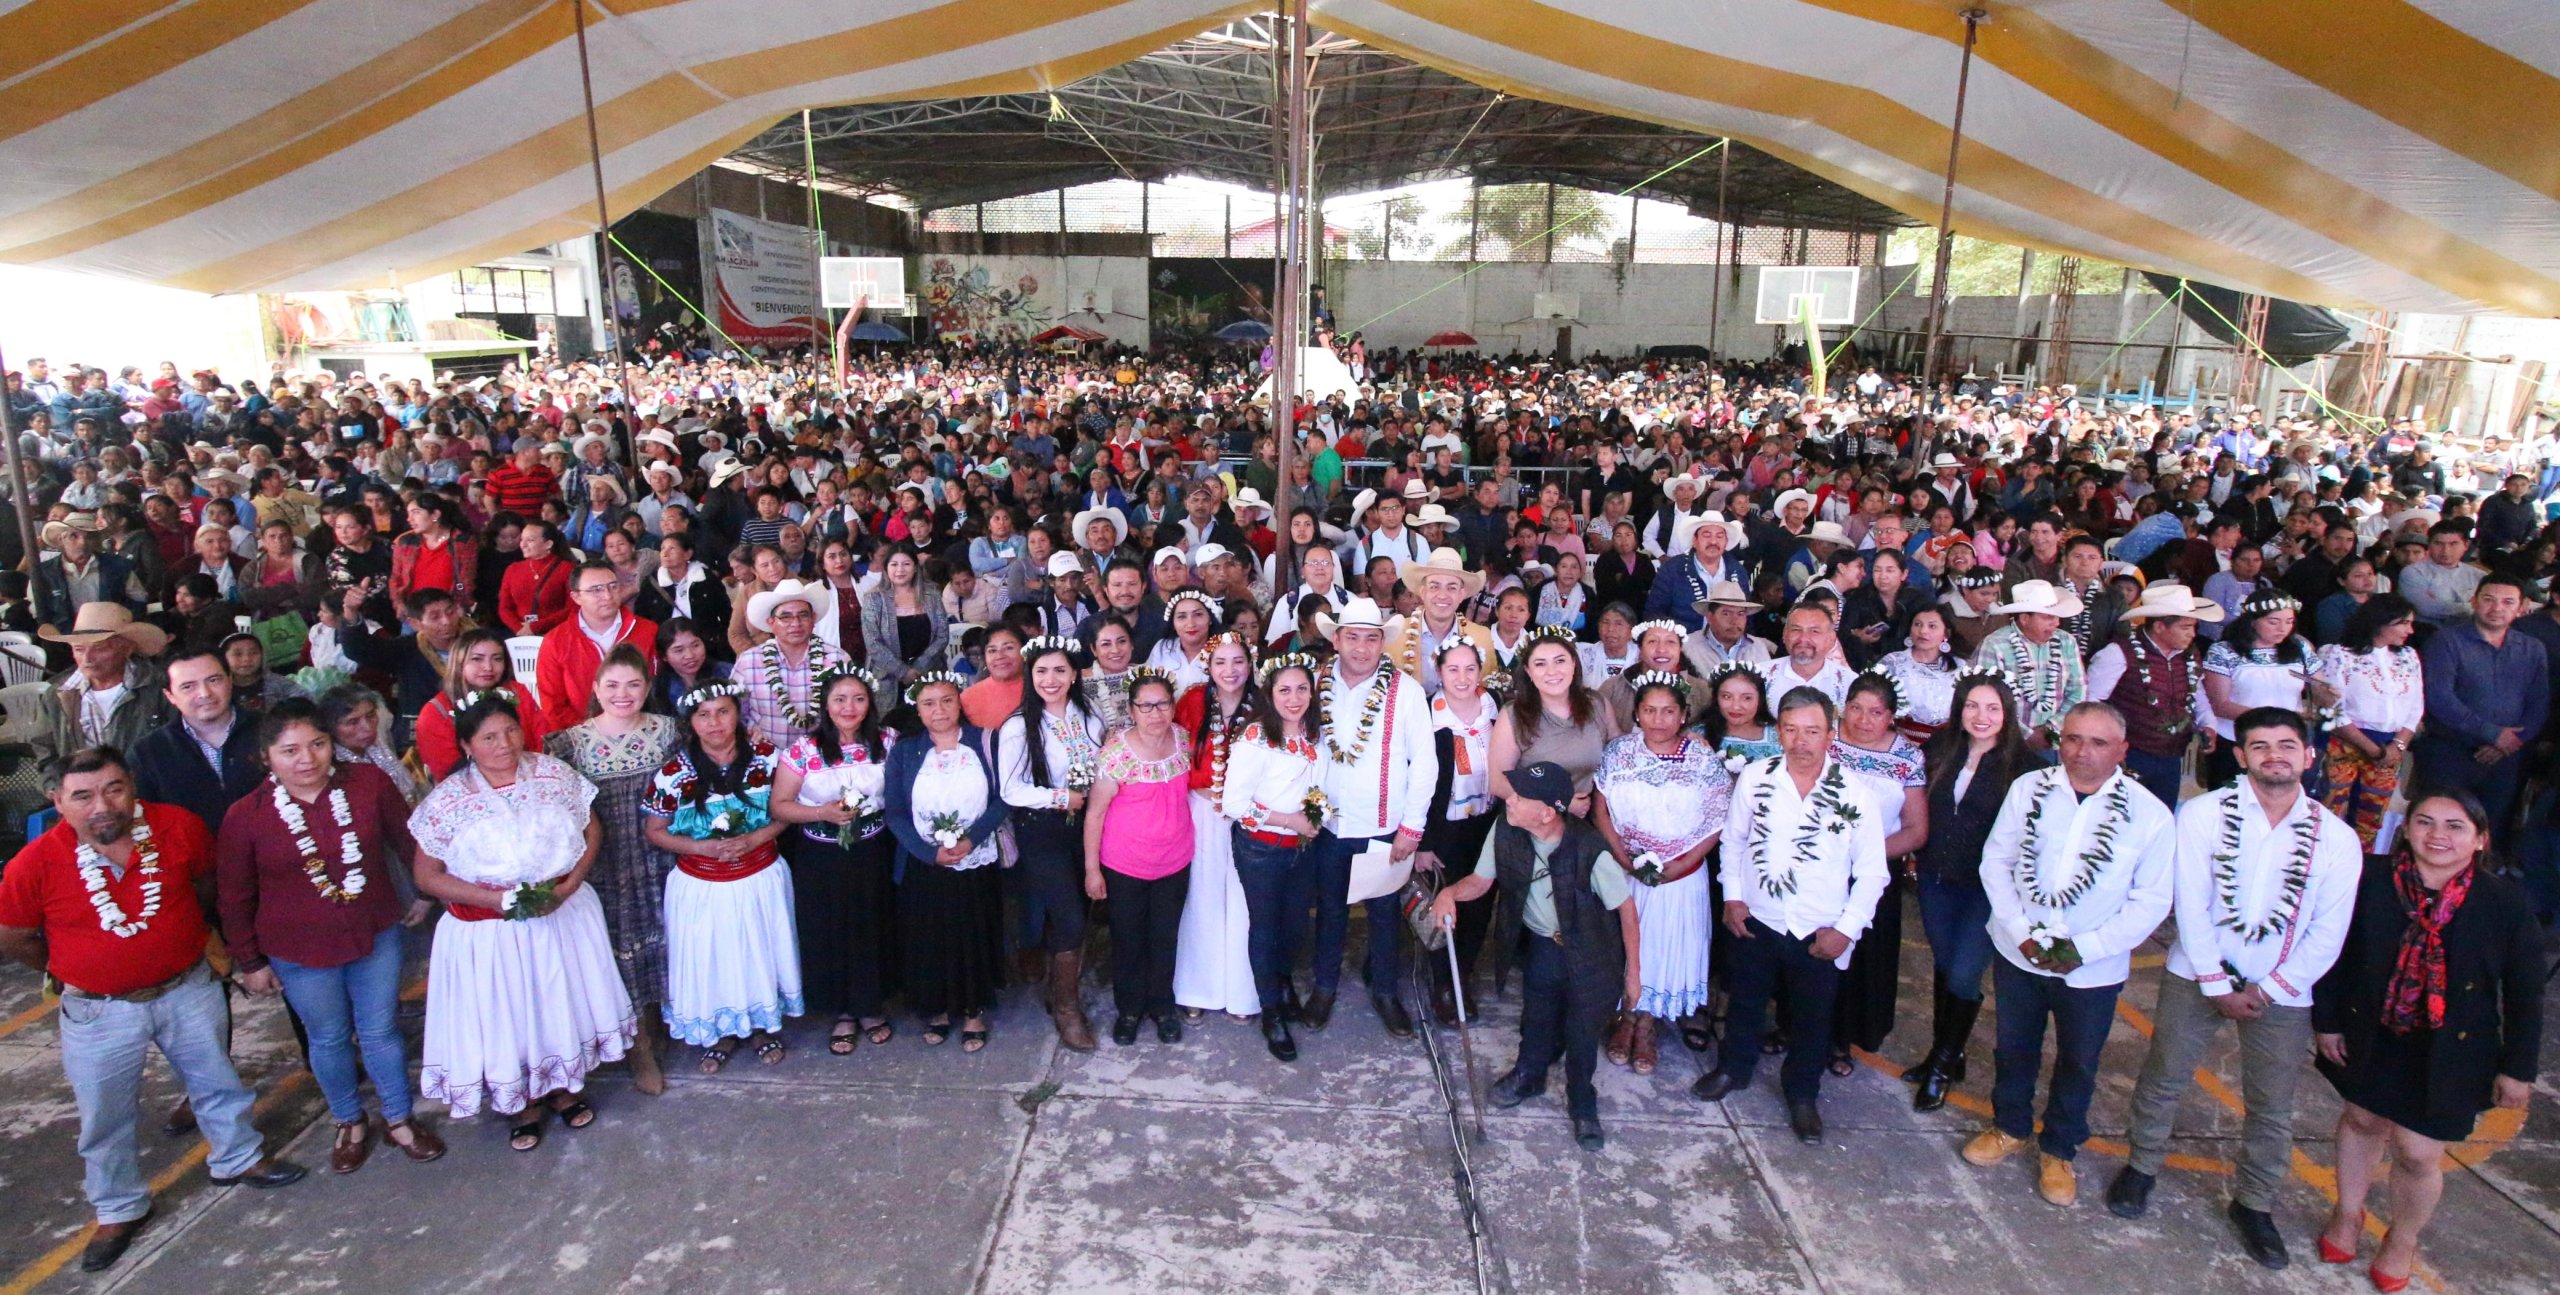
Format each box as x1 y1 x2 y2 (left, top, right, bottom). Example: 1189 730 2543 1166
417 888 640 1118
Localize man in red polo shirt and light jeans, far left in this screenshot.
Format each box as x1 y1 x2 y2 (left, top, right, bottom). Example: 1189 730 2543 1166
0 747 302 1272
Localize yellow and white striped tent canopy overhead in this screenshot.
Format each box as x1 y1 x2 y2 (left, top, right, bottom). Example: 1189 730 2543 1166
0 0 2560 315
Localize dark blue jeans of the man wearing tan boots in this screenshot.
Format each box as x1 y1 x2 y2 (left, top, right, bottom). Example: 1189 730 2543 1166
1992 957 2125 1159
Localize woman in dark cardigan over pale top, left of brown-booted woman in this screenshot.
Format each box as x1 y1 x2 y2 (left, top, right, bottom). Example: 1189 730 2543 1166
883 671 1006 1052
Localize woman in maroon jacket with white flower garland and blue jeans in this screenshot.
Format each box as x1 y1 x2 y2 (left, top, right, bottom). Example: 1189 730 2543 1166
215 699 445 1175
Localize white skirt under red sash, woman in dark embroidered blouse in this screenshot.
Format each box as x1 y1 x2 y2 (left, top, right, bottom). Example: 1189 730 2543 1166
666 860 809 1047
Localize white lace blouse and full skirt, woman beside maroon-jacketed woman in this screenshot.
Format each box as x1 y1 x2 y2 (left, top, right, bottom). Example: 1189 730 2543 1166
410 752 640 1118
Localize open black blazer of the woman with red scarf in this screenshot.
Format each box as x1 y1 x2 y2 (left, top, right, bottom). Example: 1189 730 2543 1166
2312 857 2545 1118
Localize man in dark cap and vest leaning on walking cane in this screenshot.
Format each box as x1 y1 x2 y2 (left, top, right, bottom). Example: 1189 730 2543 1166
1431 760 1636 1152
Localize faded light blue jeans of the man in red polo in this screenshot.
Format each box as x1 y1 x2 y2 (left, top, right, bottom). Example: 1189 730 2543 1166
61 962 266 1223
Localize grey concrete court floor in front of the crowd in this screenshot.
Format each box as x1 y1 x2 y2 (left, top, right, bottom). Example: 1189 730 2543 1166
0 921 2560 1295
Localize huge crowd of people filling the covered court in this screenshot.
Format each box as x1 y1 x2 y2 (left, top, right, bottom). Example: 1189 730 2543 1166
0 335 2560 1290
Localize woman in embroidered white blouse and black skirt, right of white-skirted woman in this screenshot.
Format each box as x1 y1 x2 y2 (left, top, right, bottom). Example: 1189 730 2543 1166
771 665 896 1057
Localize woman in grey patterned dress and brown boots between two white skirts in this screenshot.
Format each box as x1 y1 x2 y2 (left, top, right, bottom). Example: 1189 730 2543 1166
545 642 684 1095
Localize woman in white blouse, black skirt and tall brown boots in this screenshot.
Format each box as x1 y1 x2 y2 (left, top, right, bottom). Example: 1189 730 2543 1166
993 635 1103 1052
